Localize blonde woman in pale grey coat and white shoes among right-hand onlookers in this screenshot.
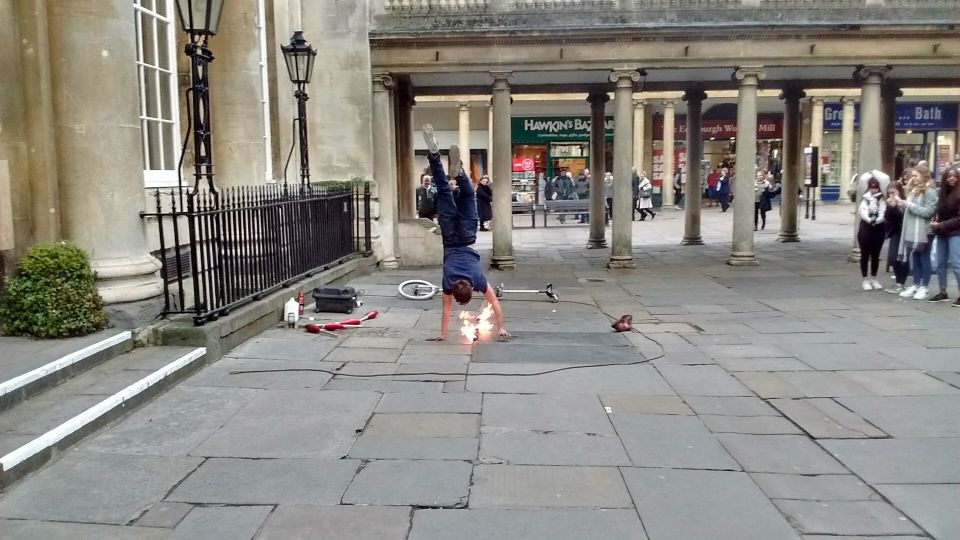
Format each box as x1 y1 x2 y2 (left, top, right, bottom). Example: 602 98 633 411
887 167 937 300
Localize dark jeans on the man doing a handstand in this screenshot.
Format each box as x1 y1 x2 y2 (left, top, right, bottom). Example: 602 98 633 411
427 154 480 246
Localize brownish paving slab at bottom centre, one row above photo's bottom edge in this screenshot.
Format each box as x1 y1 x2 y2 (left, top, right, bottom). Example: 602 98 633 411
470 465 633 509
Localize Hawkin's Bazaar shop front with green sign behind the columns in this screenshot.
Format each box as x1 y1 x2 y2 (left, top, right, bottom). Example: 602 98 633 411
511 116 613 204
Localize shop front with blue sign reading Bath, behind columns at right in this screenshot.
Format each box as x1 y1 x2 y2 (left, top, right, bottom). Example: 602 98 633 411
820 102 958 185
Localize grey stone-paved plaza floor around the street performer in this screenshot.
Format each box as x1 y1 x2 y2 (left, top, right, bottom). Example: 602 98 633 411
0 205 960 540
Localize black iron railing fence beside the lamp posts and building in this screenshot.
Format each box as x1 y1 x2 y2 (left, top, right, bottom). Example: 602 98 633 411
142 182 373 326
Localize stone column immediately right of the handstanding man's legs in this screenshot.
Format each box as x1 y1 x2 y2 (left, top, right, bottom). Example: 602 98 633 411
490 71 517 270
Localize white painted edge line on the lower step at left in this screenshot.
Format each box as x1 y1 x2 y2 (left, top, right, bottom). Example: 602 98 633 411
0 347 207 471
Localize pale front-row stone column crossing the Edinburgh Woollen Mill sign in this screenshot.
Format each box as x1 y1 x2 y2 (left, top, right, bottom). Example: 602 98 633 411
727 66 765 266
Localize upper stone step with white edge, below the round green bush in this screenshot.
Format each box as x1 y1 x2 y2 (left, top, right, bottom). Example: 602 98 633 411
0 330 133 411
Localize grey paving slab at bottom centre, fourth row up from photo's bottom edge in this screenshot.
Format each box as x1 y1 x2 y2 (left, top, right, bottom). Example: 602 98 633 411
483 394 615 435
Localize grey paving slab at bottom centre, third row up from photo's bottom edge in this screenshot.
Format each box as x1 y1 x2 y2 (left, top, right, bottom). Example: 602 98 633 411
480 428 631 466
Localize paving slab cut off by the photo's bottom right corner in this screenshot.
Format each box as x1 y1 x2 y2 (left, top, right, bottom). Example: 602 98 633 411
876 484 960 538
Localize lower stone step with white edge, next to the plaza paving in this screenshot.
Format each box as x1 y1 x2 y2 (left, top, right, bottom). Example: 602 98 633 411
0 347 206 487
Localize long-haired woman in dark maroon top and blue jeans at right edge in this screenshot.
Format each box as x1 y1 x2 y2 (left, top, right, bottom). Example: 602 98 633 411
930 168 960 307
